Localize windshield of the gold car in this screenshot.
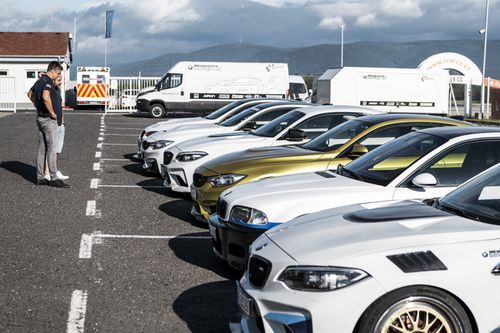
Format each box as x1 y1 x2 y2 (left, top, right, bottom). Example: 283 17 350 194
304 119 372 152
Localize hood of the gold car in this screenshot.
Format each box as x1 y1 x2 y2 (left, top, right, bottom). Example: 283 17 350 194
203 146 323 173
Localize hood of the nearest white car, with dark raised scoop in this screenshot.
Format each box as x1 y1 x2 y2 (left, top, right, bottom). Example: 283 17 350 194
266 201 500 265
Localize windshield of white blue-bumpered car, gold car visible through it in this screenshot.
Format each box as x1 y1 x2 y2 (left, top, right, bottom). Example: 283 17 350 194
344 132 447 186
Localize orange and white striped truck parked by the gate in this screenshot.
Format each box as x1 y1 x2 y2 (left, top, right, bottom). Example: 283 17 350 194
76 66 110 107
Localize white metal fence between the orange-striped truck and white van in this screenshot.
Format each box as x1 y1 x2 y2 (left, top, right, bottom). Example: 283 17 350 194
106 77 160 113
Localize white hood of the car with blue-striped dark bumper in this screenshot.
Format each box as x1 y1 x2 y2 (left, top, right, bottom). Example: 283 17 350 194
221 171 380 223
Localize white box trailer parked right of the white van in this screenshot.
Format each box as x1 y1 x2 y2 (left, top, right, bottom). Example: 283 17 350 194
317 67 449 115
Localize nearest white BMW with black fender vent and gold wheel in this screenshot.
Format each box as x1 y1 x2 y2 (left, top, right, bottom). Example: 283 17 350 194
238 161 500 333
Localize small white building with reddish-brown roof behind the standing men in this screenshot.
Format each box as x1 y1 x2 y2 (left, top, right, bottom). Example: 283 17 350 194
0 32 73 109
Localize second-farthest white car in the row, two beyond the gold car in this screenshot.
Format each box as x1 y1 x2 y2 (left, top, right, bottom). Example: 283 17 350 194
140 101 311 173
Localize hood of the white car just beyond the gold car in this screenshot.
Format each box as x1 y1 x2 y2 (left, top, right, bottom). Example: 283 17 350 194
177 132 270 155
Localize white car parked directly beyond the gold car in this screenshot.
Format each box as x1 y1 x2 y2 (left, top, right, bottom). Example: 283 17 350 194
165 103 380 193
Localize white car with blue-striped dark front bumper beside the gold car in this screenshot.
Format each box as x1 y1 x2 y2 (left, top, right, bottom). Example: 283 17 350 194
213 126 500 268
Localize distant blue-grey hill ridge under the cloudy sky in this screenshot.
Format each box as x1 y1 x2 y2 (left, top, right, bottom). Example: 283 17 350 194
111 40 500 79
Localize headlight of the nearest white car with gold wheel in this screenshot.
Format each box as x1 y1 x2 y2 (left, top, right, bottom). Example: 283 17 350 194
279 266 369 291
